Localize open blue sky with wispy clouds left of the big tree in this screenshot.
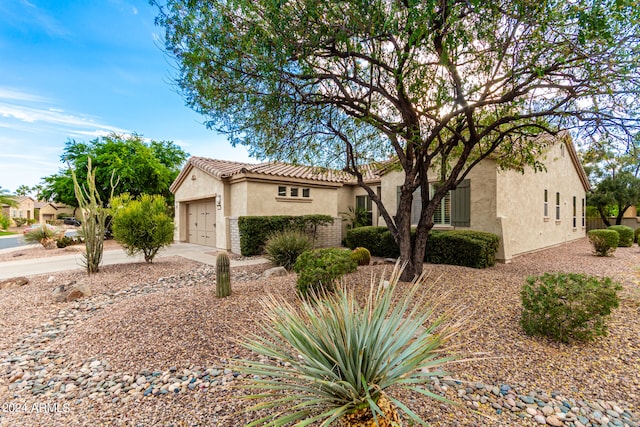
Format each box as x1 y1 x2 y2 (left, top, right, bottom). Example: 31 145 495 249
0 0 252 191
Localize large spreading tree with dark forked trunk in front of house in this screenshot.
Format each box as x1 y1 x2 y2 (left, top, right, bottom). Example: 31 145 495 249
152 0 640 279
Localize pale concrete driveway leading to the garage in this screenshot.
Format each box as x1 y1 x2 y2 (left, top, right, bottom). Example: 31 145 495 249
0 243 268 279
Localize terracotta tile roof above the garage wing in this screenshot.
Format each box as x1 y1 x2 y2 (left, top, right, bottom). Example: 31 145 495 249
171 156 381 191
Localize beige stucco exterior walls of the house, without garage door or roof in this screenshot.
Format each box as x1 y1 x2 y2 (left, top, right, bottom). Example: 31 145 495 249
172 139 588 262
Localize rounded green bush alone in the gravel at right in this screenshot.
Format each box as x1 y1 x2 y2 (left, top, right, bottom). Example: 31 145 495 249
520 273 622 342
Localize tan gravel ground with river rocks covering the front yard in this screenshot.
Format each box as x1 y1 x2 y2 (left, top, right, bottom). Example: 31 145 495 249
0 239 640 427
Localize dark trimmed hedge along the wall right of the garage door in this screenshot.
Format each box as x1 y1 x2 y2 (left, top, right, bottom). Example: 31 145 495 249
238 215 333 256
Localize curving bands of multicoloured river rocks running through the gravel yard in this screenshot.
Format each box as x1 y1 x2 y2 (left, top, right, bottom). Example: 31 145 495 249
0 266 640 427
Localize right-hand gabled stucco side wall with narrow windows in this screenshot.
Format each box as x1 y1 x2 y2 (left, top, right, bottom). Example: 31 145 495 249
497 143 585 259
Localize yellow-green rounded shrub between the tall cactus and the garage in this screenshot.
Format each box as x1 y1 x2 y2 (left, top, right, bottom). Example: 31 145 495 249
110 193 174 262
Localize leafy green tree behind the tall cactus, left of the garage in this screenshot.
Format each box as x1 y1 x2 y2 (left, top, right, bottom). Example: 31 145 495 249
42 133 188 206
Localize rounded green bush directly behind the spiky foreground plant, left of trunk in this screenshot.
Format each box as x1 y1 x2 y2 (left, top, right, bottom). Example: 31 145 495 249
293 248 358 297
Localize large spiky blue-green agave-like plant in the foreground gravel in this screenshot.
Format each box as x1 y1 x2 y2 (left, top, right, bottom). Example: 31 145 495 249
237 265 460 426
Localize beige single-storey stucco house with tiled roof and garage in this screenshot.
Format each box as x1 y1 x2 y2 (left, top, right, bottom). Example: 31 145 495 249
171 135 589 262
